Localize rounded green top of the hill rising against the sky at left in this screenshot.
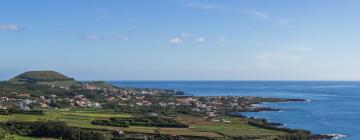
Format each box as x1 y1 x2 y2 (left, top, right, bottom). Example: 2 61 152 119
8 71 74 84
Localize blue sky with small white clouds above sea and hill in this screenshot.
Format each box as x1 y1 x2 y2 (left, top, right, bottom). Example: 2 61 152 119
0 0 360 80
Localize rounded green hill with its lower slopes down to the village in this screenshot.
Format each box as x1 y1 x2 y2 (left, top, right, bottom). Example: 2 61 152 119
0 71 116 98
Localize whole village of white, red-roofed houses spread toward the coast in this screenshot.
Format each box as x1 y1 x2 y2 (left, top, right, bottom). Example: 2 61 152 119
0 82 293 118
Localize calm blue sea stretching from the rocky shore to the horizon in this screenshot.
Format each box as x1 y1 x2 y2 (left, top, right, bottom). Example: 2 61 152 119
110 81 360 140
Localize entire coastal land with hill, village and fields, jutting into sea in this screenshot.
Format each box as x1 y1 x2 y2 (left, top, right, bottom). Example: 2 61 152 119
0 71 336 140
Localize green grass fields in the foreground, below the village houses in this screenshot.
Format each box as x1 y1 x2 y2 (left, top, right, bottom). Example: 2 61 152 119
0 110 285 140
